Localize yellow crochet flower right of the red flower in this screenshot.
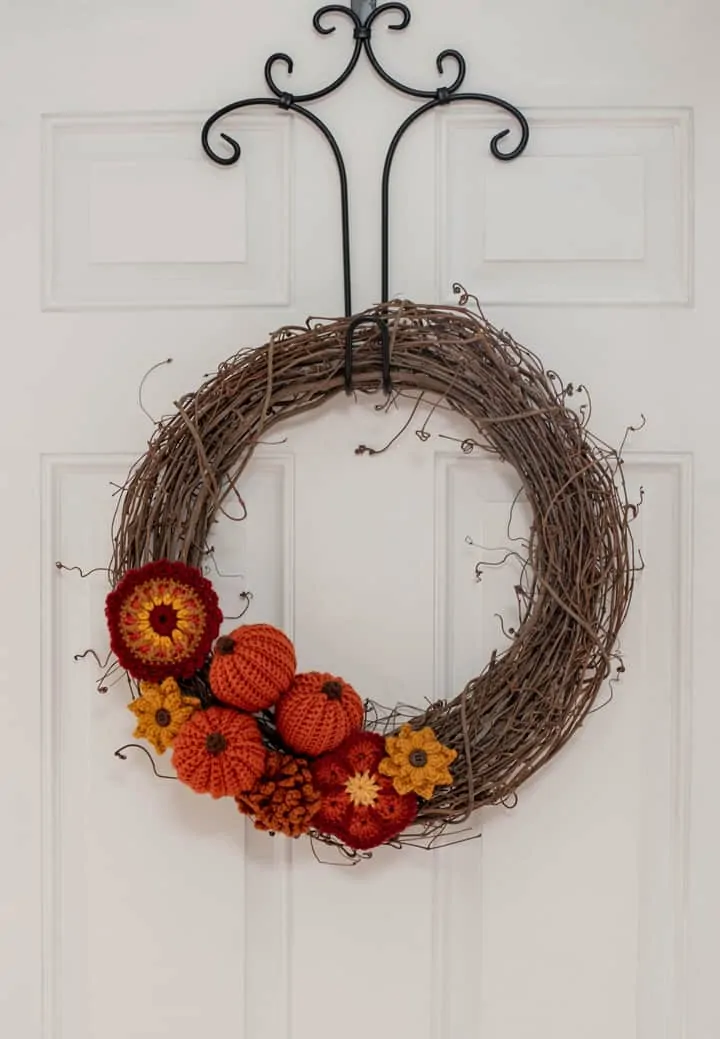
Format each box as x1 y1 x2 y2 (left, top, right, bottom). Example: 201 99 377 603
378 725 457 800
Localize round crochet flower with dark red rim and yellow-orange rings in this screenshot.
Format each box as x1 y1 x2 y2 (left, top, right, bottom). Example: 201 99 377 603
105 559 222 682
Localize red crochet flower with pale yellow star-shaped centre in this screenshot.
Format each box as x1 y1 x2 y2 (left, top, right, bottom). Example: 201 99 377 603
312 732 418 851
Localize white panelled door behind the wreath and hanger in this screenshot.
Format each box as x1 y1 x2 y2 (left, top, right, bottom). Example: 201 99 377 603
0 0 720 1039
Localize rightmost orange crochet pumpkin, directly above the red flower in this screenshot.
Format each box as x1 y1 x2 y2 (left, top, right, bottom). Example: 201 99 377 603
275 671 365 757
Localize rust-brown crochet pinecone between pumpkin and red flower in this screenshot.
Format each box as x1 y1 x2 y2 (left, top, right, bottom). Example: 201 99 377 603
235 751 320 837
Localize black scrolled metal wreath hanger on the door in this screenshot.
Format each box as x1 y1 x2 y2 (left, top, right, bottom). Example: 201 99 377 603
202 0 530 392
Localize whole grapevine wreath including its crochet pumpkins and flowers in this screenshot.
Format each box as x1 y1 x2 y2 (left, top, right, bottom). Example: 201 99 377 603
99 295 637 857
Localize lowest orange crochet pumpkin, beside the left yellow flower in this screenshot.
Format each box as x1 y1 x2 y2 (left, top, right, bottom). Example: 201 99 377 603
172 708 266 797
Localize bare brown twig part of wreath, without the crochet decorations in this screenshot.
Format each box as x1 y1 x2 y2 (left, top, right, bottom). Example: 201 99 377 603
110 301 636 833
